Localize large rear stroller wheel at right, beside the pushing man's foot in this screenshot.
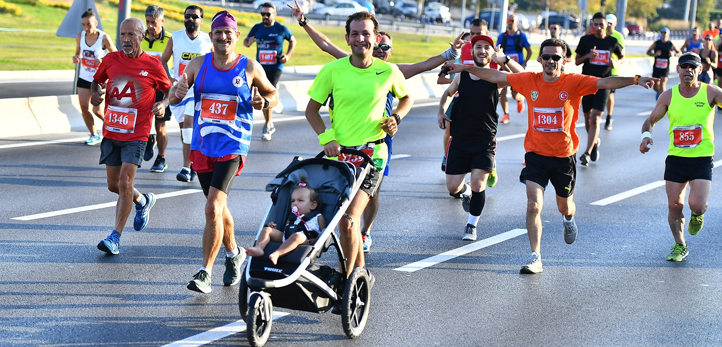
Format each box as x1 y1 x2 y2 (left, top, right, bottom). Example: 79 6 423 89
341 267 371 339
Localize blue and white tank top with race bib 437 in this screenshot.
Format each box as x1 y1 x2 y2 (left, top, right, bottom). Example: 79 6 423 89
191 53 253 158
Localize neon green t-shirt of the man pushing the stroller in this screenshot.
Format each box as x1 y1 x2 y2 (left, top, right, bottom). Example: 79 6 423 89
308 57 408 147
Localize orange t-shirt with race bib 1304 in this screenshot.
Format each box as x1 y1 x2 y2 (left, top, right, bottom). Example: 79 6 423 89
506 72 599 158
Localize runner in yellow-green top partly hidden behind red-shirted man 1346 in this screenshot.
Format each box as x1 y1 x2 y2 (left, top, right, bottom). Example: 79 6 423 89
141 5 171 172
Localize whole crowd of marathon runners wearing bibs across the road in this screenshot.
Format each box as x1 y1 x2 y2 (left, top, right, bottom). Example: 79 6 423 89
73 3 722 293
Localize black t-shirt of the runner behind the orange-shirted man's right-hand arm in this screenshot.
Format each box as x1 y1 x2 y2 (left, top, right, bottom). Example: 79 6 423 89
576 34 622 77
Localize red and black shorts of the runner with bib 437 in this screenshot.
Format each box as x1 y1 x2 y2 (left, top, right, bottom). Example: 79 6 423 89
189 150 246 196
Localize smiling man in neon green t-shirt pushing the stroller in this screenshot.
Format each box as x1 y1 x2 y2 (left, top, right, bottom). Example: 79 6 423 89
306 12 413 283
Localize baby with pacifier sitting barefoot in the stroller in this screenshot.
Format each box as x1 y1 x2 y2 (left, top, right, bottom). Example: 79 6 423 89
246 177 326 265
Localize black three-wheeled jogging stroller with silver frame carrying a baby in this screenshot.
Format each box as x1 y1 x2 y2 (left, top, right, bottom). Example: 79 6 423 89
238 149 373 346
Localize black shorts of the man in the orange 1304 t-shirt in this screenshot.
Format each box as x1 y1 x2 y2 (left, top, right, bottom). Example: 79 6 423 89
519 152 577 198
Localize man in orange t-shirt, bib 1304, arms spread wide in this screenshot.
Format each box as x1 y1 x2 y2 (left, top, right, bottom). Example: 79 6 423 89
444 36 657 274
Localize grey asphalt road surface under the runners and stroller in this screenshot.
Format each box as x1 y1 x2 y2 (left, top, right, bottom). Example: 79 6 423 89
0 80 722 346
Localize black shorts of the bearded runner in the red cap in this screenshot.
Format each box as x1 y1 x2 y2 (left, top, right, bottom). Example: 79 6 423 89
446 137 496 175
